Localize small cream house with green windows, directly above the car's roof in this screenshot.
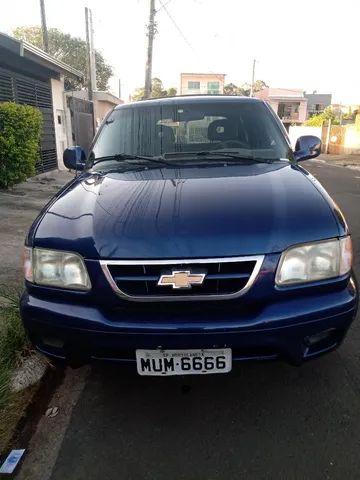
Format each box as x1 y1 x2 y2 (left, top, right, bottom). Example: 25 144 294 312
180 73 225 95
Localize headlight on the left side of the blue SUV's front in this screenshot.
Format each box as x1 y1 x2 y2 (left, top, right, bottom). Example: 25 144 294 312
24 247 91 290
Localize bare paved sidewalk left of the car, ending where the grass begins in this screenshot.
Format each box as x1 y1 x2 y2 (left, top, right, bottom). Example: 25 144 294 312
0 170 73 286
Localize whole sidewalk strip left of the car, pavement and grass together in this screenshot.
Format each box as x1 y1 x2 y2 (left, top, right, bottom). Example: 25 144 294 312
0 171 73 454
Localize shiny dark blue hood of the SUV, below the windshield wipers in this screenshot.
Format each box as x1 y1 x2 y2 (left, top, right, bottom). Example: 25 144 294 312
30 163 339 259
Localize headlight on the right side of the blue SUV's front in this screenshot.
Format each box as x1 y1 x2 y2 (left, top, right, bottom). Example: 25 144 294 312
275 237 352 286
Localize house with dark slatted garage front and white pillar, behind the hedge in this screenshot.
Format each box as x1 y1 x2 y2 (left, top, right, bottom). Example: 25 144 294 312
0 33 83 173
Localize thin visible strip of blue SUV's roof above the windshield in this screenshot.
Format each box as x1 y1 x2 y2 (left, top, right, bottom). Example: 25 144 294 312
115 95 263 110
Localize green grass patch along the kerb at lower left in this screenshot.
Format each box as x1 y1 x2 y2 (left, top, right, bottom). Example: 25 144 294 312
0 287 30 451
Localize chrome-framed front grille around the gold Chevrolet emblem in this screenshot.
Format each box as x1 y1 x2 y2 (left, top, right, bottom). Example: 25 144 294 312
101 256 263 301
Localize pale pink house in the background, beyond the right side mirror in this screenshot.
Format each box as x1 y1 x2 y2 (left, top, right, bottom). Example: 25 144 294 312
255 88 307 130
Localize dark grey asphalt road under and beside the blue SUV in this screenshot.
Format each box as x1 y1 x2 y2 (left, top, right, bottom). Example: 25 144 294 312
41 162 360 480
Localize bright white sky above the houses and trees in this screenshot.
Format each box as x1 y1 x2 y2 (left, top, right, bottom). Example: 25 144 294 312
0 0 360 104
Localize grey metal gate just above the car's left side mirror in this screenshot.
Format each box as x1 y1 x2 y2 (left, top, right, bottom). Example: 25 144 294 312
68 97 95 155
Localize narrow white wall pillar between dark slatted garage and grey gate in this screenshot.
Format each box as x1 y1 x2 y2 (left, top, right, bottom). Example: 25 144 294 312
51 75 68 170
